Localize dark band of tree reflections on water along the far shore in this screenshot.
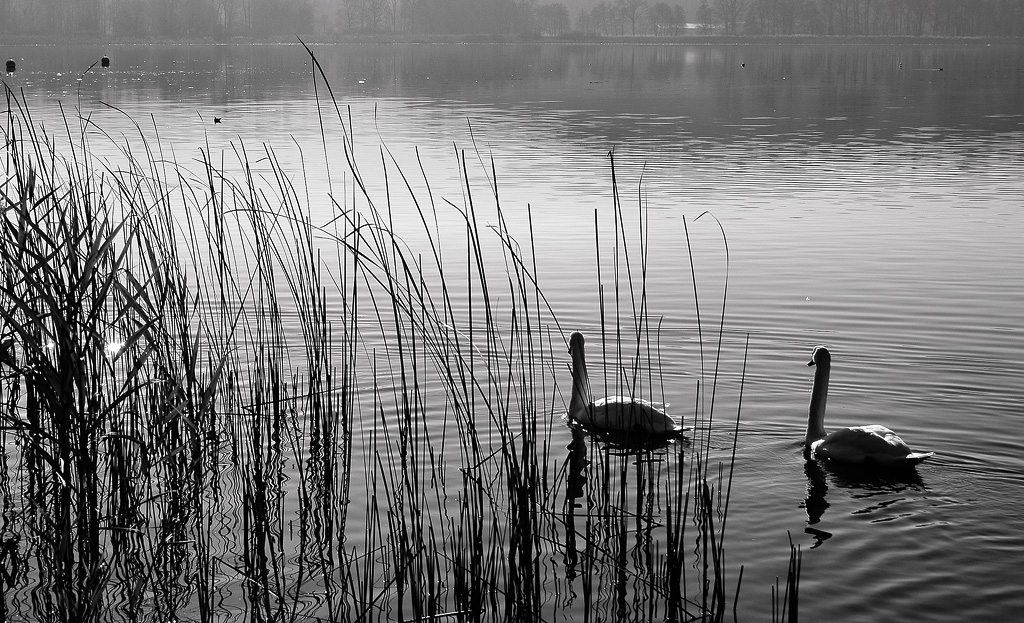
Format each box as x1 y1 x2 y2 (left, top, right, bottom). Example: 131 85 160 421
8 44 1021 152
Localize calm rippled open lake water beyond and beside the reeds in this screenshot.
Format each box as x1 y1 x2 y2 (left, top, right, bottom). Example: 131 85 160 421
6 43 1024 622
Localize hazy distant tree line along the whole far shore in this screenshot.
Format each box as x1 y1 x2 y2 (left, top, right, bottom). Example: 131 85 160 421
0 0 1024 39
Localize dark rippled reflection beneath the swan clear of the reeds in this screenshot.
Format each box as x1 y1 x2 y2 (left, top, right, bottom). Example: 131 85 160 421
800 451 925 549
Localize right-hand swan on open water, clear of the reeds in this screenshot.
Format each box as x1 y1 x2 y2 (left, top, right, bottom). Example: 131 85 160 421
804 346 935 466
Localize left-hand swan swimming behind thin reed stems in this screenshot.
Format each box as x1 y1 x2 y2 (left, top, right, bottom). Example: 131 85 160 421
568 331 683 438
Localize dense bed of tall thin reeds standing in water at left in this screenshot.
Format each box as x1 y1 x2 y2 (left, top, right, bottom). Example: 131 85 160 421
0 58 799 622
